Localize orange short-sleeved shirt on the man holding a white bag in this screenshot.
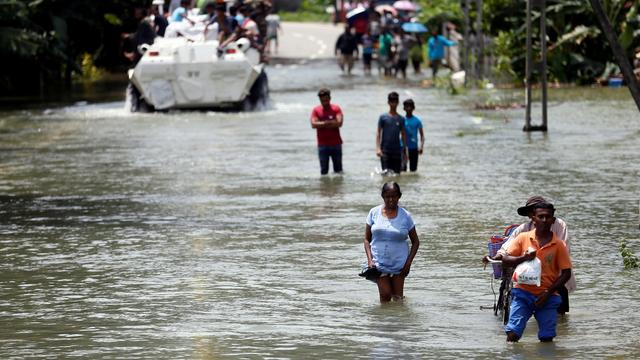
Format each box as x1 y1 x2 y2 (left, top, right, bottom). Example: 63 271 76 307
507 229 571 296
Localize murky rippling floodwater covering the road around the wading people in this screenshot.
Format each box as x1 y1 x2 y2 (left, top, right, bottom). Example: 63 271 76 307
0 62 640 359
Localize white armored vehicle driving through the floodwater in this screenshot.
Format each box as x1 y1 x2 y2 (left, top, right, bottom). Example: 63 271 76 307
129 36 269 111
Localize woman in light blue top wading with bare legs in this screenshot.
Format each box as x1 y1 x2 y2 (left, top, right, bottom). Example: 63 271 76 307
364 182 420 303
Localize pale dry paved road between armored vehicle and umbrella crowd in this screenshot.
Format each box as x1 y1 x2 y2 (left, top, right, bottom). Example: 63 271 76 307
273 22 344 60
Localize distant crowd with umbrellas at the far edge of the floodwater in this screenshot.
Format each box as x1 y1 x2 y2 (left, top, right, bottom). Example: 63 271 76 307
335 1 462 78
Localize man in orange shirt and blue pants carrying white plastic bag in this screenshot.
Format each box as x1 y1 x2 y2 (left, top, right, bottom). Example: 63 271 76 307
502 202 571 342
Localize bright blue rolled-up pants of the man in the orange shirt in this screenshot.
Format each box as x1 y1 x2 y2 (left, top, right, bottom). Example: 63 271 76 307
504 288 562 340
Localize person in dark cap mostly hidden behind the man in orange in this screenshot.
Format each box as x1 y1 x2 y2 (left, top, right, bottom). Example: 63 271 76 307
484 195 576 314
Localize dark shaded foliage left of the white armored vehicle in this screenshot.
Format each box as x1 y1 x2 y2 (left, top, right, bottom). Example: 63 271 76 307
0 0 144 95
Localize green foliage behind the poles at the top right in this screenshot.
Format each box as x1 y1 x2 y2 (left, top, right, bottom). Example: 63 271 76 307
417 0 640 83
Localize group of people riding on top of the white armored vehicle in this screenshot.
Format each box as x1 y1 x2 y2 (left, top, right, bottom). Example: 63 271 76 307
123 0 281 63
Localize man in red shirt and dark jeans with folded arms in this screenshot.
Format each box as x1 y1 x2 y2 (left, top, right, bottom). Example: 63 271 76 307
311 88 342 175
